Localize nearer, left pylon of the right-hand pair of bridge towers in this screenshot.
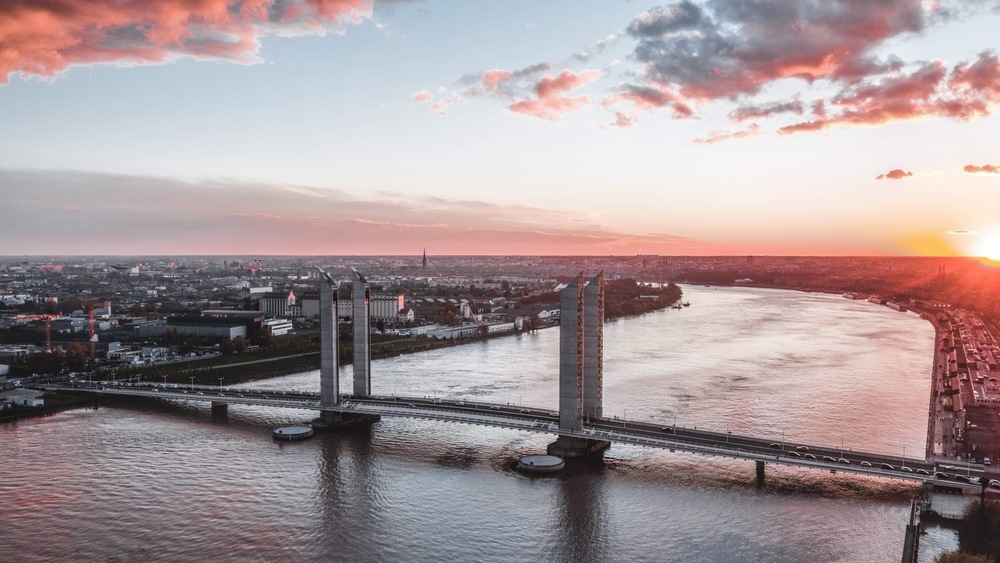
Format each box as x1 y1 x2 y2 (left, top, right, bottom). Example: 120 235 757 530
559 273 584 430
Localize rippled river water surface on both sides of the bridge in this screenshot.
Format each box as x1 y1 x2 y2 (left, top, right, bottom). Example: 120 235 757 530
0 286 956 563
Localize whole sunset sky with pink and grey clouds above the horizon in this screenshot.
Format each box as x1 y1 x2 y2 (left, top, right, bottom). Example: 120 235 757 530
0 0 1000 259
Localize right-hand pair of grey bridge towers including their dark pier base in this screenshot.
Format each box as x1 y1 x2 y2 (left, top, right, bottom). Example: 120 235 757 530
548 272 610 457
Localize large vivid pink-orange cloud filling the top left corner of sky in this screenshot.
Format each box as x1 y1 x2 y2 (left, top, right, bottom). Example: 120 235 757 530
0 0 372 84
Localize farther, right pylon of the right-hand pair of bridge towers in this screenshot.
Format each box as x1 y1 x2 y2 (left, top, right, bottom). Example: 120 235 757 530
583 272 604 419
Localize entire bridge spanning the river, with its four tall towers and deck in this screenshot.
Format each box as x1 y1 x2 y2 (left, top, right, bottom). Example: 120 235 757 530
52 271 983 486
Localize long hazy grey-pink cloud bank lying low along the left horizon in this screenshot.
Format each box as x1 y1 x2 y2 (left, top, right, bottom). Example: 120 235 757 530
0 170 719 255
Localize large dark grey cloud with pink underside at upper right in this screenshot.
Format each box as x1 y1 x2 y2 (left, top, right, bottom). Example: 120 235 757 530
627 0 926 99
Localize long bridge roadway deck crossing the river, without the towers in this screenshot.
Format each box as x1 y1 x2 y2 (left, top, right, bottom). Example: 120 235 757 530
54 383 1000 488
